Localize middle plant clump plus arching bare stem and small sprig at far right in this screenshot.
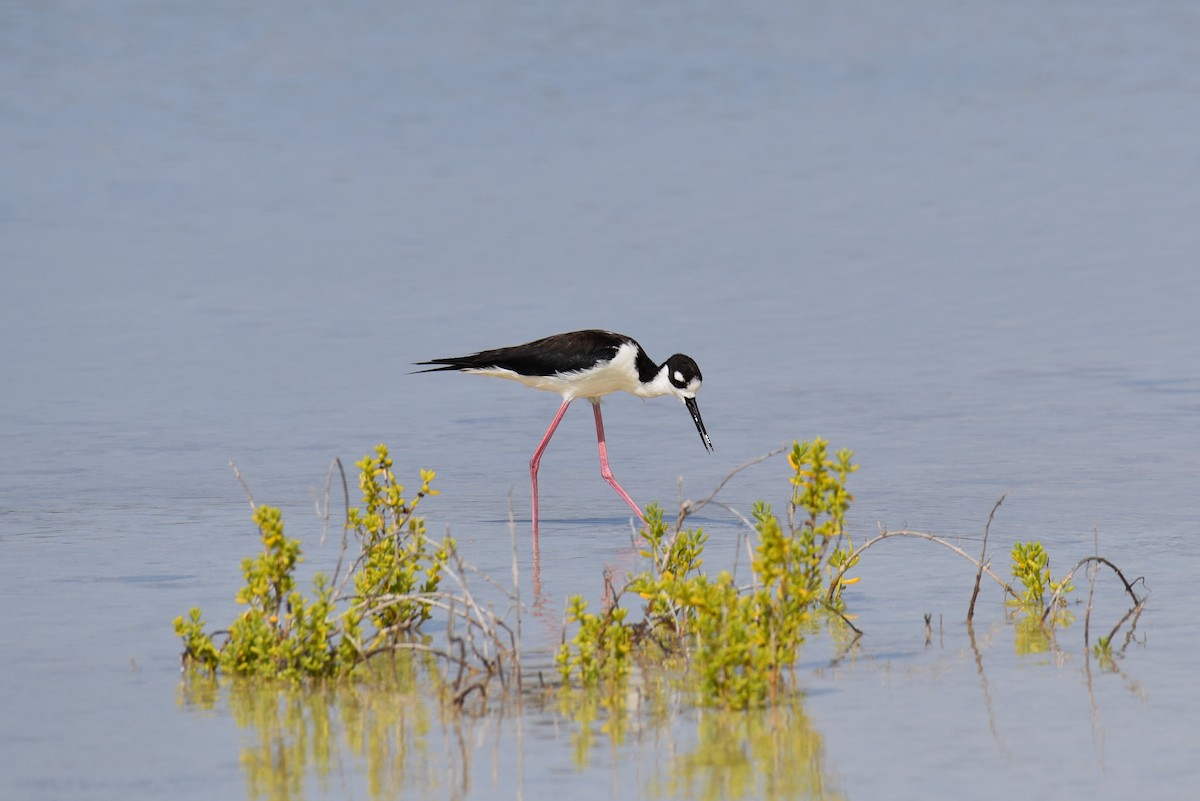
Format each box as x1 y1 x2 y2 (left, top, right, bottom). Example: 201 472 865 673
557 438 1144 709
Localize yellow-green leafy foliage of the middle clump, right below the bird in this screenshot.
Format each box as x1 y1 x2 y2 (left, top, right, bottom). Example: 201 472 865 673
558 439 857 707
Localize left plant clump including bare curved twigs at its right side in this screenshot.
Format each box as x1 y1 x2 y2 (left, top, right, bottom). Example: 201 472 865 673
174 445 516 703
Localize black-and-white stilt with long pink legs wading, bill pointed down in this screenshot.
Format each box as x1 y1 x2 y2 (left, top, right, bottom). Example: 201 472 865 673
416 330 713 537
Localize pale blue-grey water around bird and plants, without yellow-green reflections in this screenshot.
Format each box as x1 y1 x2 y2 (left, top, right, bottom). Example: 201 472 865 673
0 0 1200 801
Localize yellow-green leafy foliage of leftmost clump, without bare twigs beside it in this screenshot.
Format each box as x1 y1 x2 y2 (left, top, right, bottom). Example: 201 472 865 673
175 445 454 680
